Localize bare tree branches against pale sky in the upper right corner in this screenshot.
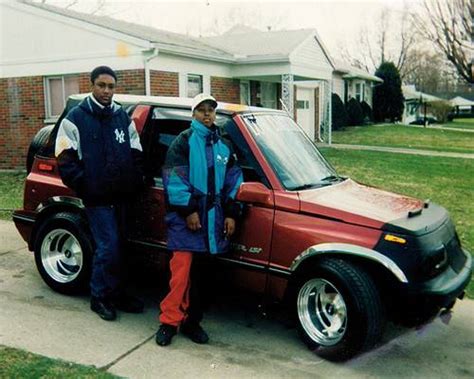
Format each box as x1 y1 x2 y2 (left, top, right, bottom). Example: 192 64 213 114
414 0 474 83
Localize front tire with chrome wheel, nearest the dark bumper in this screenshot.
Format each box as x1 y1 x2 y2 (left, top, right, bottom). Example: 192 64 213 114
296 258 385 361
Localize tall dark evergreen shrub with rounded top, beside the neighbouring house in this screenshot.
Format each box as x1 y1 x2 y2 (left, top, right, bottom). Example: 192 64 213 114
374 62 403 122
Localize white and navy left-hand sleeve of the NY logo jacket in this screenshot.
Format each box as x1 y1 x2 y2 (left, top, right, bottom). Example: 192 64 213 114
55 118 84 193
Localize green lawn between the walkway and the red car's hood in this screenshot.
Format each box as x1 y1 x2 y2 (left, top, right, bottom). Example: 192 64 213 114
321 148 474 298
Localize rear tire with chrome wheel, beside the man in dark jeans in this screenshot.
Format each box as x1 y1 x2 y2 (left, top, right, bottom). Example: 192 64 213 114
34 212 93 295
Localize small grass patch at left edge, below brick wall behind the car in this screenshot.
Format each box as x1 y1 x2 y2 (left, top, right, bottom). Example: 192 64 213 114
0 172 26 220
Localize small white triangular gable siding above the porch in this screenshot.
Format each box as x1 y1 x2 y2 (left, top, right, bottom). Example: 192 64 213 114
290 35 333 80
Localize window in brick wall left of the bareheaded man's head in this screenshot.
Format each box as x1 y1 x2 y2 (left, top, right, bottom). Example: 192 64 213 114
45 76 79 118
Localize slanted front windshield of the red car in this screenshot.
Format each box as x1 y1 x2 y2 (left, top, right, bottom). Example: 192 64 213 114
242 113 342 190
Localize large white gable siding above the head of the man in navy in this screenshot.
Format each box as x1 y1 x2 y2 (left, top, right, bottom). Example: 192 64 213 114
0 2 148 77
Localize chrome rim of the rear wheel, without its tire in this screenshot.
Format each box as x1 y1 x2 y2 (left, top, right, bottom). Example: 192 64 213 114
41 229 83 283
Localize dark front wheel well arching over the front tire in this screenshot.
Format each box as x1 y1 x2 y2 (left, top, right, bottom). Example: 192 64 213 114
285 253 399 308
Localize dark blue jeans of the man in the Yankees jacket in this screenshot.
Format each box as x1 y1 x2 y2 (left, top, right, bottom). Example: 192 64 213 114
86 205 122 298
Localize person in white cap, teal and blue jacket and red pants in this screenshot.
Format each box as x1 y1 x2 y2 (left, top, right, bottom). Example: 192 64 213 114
155 94 242 346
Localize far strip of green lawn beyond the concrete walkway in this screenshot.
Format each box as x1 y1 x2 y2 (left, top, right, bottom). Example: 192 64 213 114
332 124 474 153
